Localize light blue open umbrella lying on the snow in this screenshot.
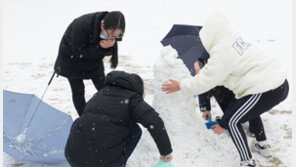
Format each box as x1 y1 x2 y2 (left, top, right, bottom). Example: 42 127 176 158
3 91 73 164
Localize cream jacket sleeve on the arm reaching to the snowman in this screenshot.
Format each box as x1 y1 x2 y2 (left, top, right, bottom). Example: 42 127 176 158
180 52 230 95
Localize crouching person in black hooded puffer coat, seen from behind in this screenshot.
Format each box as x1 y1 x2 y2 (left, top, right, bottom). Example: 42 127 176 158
65 71 172 167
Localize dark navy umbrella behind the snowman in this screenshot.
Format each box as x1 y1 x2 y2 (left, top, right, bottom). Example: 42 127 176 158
161 24 210 76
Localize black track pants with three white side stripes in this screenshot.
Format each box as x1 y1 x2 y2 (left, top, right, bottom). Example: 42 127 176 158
220 80 289 161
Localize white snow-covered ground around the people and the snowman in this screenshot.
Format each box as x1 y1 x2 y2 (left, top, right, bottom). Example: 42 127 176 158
3 0 293 167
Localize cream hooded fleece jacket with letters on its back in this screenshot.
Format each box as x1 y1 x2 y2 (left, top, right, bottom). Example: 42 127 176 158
180 13 287 99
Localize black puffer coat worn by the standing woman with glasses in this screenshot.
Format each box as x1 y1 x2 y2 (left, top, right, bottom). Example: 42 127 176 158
54 12 117 79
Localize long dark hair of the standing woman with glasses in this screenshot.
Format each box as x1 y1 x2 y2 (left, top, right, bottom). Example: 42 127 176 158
104 11 125 69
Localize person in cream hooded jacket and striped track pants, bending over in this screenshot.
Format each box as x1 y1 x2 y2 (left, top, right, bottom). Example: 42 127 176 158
162 13 289 166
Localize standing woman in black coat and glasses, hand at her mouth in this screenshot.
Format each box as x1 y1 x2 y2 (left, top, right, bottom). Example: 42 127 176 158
54 11 125 116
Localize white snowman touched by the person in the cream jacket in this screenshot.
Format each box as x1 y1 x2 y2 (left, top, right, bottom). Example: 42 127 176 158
153 46 197 129
